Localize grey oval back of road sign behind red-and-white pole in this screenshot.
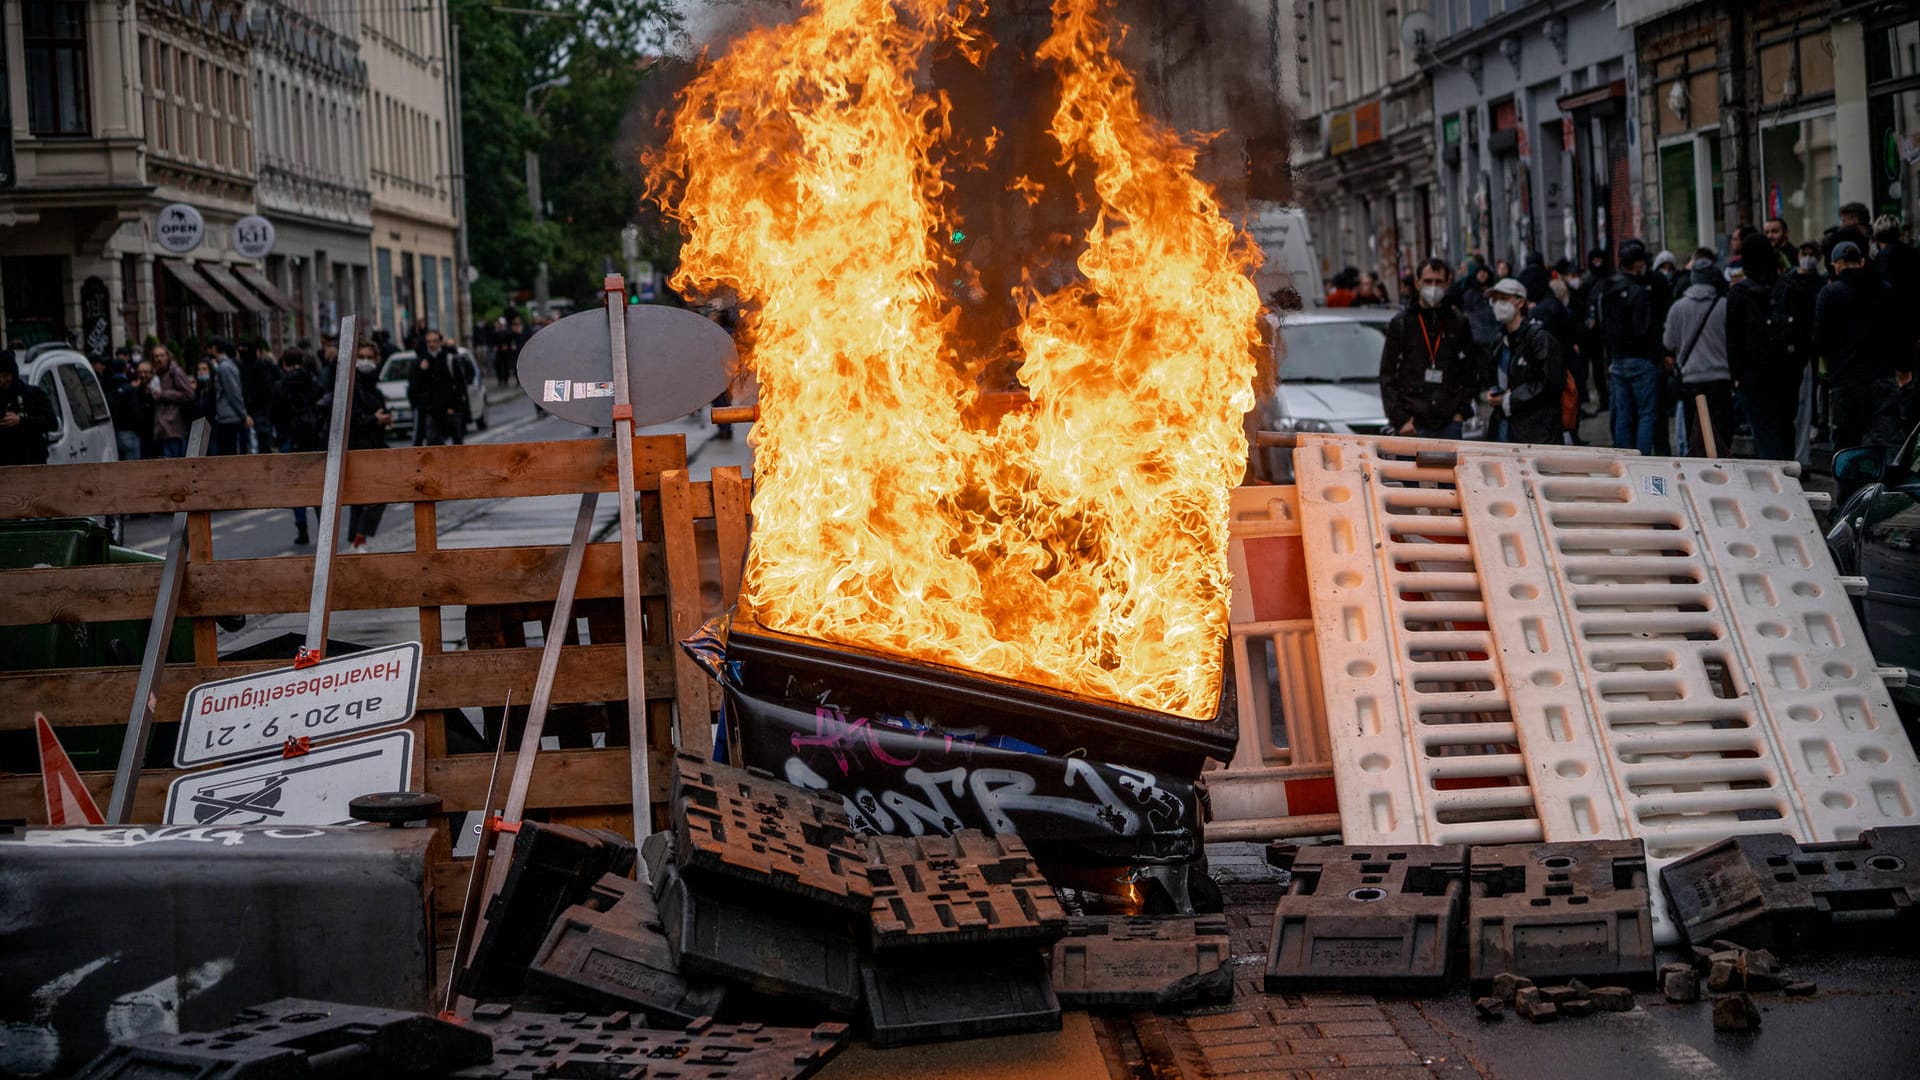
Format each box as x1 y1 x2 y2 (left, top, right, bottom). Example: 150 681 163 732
520 304 733 427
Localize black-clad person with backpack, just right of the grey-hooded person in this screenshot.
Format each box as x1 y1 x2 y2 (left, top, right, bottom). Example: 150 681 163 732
1726 233 1807 461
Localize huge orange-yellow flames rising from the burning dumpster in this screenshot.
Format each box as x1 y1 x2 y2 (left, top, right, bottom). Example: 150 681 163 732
655 0 1260 719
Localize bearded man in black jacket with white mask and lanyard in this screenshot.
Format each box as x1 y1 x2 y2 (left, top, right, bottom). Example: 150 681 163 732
1380 259 1478 438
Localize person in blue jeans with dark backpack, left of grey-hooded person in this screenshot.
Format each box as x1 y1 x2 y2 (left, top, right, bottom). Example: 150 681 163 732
1594 240 1667 454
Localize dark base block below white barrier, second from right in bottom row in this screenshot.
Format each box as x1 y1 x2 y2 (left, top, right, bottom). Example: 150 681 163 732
1467 840 1653 986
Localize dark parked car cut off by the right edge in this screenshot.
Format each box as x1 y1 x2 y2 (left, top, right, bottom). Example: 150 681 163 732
1826 427 1920 724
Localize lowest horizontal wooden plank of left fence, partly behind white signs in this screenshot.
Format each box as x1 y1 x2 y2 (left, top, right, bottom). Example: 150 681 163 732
0 748 672 824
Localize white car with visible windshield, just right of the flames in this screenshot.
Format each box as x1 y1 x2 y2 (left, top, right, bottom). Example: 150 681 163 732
1254 307 1394 482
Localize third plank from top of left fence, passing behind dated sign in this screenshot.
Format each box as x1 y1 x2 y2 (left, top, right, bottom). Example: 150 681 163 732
0 644 674 730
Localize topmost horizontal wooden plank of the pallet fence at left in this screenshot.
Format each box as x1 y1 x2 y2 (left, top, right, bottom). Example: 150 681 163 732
0 434 712 521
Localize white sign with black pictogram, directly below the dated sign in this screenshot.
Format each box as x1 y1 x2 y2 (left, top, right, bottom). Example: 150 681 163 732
165 732 413 826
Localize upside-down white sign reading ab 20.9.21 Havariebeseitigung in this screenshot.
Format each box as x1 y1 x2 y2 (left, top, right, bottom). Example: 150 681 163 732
173 642 420 764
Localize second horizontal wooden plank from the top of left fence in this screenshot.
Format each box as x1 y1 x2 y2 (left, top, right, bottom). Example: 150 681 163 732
0 541 666 626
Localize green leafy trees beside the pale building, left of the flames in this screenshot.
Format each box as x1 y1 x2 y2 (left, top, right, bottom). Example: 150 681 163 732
449 0 680 319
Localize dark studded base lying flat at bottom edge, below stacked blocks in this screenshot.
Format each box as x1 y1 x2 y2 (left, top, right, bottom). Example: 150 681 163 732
453 1005 847 1080
